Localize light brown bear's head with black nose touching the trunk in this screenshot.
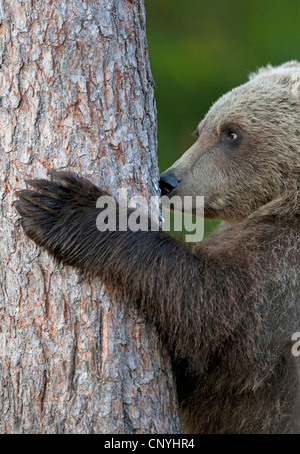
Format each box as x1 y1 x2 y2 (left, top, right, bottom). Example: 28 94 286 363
160 61 300 221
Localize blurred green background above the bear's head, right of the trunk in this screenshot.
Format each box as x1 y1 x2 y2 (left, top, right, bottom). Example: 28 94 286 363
145 0 300 238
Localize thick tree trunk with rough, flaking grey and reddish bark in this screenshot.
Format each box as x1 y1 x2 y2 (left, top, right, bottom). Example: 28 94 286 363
0 0 179 433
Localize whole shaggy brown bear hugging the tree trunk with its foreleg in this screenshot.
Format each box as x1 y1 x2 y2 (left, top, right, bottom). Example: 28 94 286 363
16 63 300 433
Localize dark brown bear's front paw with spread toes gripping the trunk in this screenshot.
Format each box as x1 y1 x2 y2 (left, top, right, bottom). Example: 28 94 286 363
15 172 105 261
